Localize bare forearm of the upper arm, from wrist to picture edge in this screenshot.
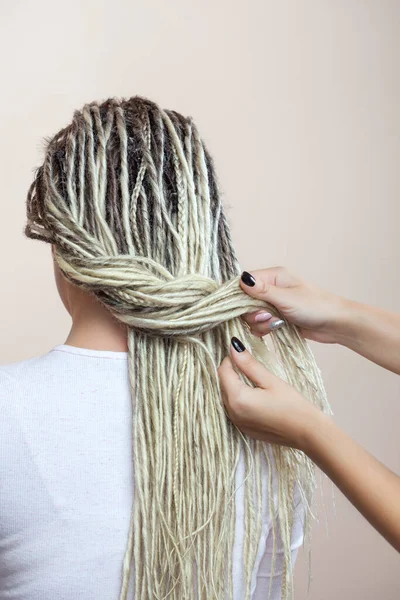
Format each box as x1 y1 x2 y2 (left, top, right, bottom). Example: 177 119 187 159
334 301 400 375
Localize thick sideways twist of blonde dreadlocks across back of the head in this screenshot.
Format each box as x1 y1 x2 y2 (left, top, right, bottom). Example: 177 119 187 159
56 252 265 338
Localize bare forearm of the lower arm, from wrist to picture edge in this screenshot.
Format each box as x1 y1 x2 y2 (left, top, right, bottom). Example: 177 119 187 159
304 413 400 552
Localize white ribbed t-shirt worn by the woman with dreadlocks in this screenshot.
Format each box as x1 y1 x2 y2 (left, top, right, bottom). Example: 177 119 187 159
0 345 303 600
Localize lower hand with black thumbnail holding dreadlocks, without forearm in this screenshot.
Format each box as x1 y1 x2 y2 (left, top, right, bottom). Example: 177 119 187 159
218 338 323 451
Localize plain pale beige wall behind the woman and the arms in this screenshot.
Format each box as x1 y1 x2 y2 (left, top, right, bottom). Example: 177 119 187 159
0 0 400 600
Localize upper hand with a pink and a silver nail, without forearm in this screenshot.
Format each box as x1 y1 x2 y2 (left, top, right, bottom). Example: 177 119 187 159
240 267 347 343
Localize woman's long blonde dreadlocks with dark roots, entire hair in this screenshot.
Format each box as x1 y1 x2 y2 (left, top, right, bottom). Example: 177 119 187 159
26 97 325 600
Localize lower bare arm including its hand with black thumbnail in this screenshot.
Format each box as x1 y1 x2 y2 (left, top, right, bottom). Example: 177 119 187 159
219 340 400 551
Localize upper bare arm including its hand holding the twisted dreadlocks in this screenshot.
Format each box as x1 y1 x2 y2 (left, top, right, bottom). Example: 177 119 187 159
240 267 400 375
